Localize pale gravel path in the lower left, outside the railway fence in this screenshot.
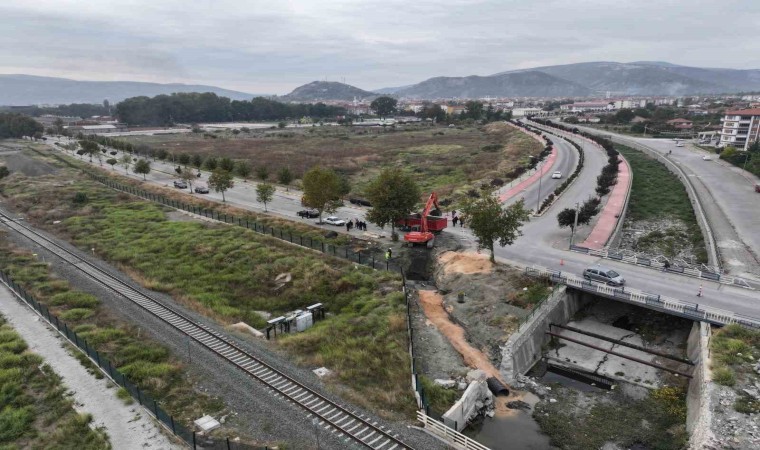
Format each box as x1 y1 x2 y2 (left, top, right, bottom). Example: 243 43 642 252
0 285 184 449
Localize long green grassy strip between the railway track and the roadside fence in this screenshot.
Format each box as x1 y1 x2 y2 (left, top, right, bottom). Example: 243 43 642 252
0 159 414 413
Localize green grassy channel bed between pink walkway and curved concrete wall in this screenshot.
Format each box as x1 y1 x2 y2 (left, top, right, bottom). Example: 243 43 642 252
615 145 707 263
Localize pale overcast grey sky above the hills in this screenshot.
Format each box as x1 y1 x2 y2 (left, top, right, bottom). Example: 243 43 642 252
0 0 760 94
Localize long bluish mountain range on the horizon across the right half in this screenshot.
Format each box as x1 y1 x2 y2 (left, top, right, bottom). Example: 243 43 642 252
386 61 760 99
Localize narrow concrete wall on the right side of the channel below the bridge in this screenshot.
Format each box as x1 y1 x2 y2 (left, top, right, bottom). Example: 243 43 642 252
686 322 714 449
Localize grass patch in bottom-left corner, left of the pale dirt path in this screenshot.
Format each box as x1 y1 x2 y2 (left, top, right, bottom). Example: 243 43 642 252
0 316 111 450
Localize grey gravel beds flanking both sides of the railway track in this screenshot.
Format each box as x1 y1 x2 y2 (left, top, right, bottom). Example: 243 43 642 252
3 203 446 450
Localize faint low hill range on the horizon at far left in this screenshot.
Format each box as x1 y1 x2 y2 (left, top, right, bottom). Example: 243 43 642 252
0 75 255 105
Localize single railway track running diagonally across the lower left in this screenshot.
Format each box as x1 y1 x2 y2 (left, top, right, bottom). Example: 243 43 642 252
0 212 412 450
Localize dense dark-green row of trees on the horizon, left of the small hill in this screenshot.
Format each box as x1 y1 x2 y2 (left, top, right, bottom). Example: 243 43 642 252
116 92 346 126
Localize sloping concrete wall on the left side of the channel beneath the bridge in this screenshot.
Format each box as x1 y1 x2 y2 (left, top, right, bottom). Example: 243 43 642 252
499 286 589 384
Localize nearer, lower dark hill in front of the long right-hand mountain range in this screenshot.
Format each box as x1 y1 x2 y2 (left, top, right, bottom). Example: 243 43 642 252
386 71 590 99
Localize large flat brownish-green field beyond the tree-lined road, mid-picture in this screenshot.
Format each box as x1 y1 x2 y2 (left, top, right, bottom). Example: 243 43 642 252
120 123 542 202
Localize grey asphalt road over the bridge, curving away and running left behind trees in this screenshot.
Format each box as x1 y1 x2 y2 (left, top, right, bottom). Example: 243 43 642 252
44 137 760 317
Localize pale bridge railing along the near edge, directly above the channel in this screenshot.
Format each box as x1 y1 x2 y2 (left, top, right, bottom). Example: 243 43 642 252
525 266 760 329
